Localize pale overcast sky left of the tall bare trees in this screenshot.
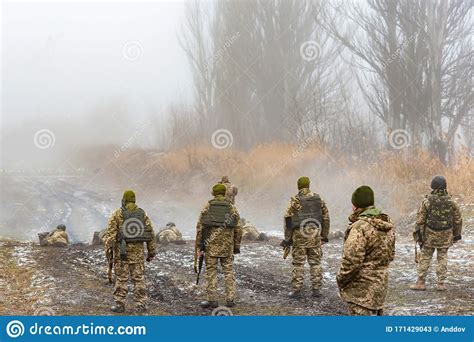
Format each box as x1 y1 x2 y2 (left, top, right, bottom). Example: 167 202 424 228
1 1 190 127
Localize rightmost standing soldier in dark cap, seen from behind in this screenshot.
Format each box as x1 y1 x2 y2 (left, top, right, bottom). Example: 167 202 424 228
410 176 462 291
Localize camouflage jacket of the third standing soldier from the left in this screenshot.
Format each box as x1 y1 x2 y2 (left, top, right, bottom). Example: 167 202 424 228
285 188 330 248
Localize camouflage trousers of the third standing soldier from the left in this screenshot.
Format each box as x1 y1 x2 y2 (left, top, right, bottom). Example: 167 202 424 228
291 246 323 291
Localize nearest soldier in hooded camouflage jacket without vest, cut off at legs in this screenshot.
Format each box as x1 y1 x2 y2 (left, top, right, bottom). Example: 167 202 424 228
336 185 395 316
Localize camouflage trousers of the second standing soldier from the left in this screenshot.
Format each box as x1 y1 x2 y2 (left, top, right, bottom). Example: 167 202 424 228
206 255 235 301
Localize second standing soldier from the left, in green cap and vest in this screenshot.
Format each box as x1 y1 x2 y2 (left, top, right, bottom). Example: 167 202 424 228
195 184 242 308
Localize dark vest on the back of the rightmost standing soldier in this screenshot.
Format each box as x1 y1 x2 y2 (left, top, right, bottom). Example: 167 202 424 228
426 194 453 231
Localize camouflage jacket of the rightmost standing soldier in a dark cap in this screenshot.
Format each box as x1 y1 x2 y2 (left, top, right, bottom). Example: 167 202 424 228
415 191 462 248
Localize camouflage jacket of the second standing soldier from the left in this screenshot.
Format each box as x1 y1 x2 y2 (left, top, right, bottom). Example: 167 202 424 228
195 196 242 258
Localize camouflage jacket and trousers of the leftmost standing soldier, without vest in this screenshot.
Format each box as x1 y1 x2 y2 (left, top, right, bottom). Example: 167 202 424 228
103 203 156 306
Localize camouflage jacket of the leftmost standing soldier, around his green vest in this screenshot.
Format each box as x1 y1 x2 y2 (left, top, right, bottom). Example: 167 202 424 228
102 204 156 264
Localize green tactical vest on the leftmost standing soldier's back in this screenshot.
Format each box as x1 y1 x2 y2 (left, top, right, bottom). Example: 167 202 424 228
120 208 154 242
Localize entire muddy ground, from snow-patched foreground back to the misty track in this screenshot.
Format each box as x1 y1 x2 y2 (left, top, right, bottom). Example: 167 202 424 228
0 176 474 315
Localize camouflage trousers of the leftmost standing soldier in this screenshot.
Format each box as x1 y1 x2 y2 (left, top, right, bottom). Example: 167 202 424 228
114 261 147 305
